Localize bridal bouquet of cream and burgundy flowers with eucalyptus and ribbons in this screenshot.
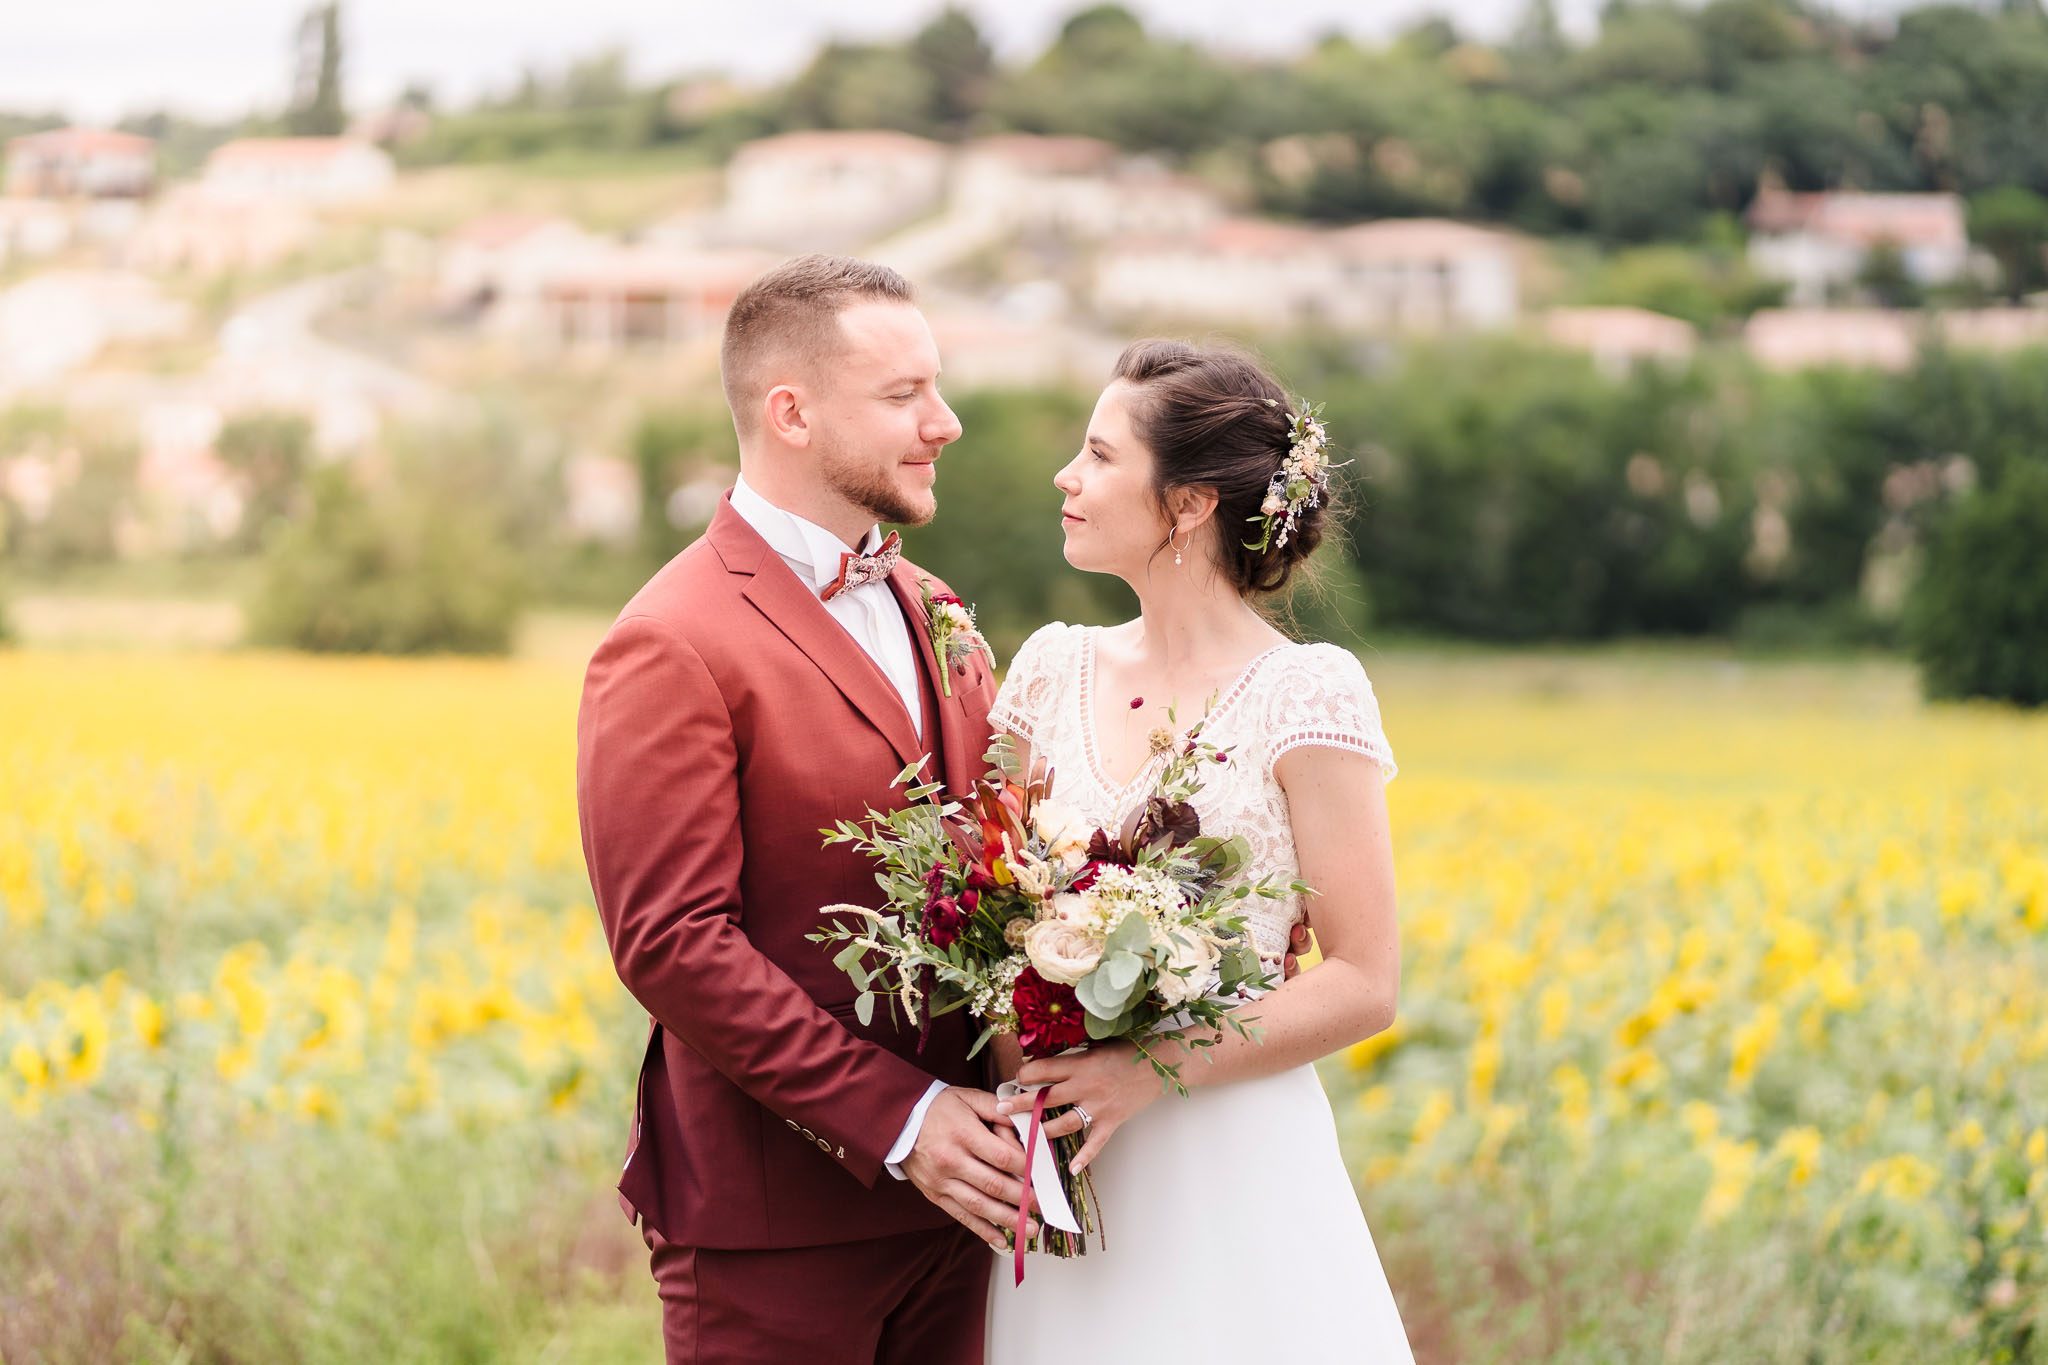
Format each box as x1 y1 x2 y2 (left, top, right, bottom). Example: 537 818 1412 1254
811 722 1309 1275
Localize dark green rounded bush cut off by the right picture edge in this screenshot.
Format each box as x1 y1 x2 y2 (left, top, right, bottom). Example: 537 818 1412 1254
1907 458 2048 706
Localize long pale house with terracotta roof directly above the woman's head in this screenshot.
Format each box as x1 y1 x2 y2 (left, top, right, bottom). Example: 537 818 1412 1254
1094 219 1520 332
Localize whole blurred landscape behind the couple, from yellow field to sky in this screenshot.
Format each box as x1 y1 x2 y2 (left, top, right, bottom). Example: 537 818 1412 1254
0 0 2048 1363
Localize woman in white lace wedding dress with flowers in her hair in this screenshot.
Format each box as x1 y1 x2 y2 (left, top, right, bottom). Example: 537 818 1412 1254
989 342 1413 1365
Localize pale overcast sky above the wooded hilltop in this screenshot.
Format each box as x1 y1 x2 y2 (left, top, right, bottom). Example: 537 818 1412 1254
0 0 1903 123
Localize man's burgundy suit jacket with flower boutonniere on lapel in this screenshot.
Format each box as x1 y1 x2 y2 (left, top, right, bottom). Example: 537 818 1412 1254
575 501 995 1248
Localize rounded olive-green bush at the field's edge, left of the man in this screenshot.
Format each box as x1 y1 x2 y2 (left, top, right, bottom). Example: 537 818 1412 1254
248 448 526 655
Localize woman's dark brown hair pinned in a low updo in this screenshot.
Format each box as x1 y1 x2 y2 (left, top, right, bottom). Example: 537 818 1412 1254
1116 340 1335 596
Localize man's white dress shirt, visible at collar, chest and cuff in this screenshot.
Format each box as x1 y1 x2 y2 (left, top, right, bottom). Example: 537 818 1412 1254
733 479 946 1181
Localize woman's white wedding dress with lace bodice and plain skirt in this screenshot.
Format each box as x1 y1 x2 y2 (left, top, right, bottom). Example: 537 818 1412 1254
987 624 1413 1365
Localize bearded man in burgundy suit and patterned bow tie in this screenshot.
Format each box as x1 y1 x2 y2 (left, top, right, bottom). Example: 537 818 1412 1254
575 256 1024 1365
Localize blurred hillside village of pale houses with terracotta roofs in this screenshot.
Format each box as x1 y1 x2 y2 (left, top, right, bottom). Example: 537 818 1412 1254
0 127 2048 553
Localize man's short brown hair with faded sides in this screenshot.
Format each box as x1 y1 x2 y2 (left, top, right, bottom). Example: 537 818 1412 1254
719 256 915 436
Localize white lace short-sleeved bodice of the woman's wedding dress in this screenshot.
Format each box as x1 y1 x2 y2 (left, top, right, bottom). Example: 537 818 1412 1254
989 622 1395 964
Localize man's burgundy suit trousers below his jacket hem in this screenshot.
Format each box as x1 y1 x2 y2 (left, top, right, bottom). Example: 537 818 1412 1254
641 1224 993 1365
